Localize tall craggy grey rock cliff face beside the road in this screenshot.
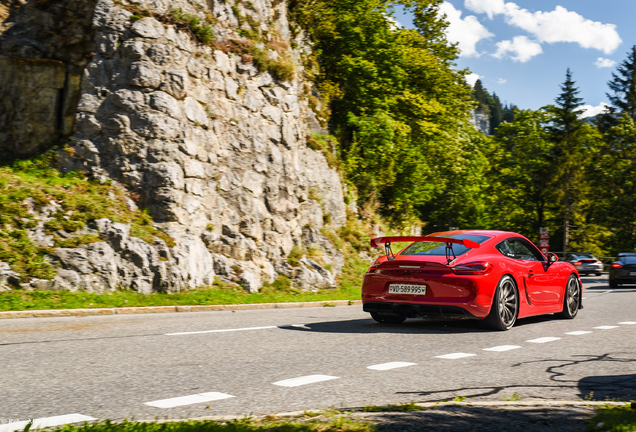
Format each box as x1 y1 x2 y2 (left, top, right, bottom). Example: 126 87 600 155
0 0 345 292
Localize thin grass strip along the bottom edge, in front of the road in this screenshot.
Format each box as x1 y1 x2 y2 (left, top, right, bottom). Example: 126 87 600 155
46 415 375 432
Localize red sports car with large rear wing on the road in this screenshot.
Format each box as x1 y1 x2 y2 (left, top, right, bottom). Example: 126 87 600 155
362 230 583 330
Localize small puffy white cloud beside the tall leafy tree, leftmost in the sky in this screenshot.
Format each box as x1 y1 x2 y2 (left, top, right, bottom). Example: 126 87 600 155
439 2 494 56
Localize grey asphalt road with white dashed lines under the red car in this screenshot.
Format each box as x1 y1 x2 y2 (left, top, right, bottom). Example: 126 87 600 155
0 276 636 431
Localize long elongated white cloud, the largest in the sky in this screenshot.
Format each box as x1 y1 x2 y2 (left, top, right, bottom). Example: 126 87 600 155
464 0 622 54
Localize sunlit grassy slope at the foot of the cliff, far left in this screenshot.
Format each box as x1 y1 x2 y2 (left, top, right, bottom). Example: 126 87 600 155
0 152 174 282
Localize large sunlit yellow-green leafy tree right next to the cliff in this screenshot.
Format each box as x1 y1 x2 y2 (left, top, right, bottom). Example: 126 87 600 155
290 0 483 224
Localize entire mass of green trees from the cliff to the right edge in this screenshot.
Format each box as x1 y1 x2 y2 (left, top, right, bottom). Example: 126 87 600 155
290 0 636 255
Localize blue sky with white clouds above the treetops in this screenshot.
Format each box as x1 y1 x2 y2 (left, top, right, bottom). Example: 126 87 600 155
395 0 636 115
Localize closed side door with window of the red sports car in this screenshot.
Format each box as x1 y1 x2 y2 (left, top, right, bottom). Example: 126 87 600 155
507 238 562 308
